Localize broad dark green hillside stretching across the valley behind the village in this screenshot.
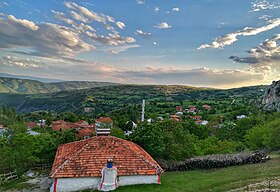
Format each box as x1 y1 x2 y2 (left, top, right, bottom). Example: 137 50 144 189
0 84 266 114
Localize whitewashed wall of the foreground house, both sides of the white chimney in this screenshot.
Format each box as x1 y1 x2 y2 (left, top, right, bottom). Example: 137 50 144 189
50 175 158 192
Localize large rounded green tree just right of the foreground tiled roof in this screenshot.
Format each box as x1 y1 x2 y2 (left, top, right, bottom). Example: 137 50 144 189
132 120 196 160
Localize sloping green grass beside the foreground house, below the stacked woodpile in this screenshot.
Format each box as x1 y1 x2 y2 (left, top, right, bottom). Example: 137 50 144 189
111 155 280 192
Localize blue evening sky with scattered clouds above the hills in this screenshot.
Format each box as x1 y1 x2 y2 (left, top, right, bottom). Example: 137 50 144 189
0 0 280 88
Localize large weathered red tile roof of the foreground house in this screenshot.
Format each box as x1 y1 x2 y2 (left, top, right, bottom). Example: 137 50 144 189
50 136 163 178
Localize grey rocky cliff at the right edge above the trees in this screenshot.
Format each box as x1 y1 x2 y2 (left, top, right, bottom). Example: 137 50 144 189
258 80 280 112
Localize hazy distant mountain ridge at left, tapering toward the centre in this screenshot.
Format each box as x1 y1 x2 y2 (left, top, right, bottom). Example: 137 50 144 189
0 77 117 94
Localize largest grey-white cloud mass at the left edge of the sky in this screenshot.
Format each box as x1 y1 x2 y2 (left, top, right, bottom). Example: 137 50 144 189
0 16 95 57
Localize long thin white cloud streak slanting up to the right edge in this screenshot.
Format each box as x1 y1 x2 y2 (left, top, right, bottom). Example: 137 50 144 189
198 18 280 49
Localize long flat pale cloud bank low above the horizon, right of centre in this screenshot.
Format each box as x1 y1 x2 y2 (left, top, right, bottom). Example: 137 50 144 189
121 66 263 88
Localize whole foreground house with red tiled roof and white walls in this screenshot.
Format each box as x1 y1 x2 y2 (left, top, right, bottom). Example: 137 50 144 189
50 136 163 192
